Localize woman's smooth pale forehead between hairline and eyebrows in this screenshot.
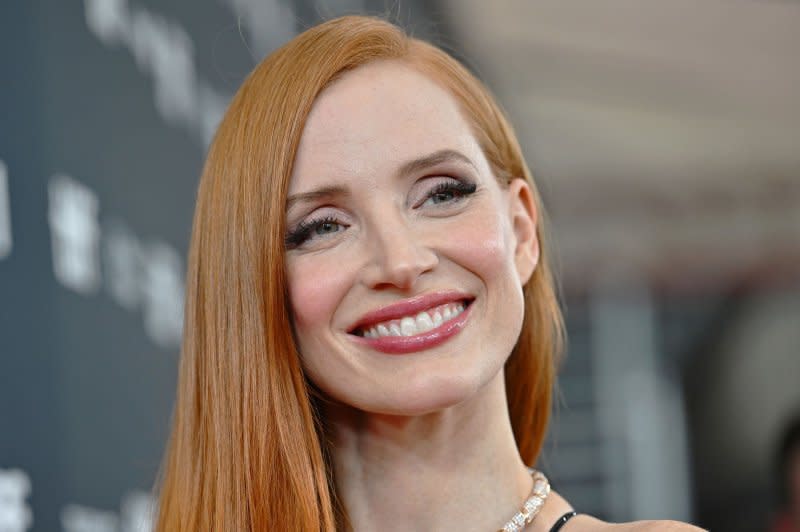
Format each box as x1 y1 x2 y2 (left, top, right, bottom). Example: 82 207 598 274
289 61 488 193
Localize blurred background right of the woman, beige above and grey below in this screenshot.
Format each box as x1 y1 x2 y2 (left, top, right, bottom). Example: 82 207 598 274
443 0 800 532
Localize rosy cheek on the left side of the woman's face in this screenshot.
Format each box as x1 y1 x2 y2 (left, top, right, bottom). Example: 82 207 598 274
287 255 347 332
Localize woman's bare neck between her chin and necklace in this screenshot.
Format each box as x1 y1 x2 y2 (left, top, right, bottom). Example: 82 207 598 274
325 372 532 531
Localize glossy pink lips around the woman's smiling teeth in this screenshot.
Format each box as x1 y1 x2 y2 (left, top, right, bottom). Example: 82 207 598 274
350 292 472 355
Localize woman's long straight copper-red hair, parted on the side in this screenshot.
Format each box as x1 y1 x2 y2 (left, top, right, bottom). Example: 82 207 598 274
156 16 562 532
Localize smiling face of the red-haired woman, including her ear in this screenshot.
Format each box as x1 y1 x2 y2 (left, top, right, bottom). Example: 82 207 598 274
286 61 538 415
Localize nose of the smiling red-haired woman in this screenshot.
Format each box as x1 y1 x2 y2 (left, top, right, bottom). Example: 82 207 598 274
362 216 439 290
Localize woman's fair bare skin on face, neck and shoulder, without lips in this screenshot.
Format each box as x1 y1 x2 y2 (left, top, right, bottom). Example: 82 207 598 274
286 61 691 531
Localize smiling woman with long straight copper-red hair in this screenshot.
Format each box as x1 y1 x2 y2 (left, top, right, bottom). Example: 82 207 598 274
158 17 691 531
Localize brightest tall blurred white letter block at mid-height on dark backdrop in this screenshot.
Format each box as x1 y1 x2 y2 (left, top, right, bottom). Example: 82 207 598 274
48 175 100 294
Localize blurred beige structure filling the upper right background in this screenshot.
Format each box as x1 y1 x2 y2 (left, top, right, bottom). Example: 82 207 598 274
445 0 800 291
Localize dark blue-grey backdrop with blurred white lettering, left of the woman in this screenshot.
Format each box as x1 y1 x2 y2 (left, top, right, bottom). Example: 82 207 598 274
0 0 447 532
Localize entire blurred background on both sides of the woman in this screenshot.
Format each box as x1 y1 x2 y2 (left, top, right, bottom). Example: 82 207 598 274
0 0 800 532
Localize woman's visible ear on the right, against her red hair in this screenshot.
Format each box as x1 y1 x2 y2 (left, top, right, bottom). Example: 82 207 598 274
508 178 539 285
